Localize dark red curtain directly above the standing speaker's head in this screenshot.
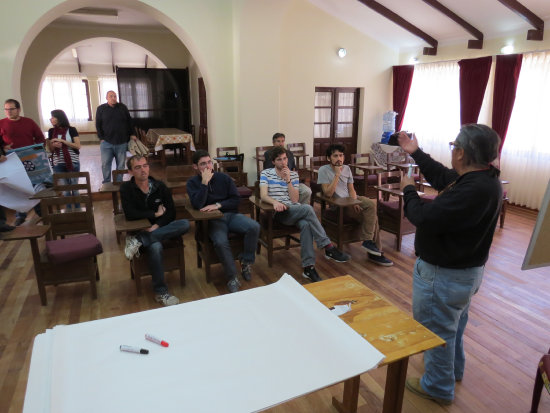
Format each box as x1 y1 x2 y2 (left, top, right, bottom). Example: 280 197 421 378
458 56 493 125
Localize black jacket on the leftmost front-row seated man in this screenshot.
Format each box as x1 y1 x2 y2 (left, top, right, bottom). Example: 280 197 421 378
120 176 176 227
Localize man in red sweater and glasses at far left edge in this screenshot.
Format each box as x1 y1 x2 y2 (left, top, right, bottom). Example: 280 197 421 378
0 99 46 226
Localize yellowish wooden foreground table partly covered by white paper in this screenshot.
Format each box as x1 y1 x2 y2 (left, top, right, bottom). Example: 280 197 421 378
304 275 445 413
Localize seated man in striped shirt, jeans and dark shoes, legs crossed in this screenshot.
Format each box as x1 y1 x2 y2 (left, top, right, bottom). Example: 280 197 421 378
260 147 350 282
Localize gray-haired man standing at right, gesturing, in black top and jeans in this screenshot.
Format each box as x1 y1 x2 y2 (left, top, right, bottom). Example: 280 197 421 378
398 124 502 405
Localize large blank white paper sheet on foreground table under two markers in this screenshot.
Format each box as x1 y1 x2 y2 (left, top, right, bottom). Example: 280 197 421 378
24 275 384 413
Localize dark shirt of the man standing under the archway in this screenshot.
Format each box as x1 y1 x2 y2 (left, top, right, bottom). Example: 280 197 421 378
95 103 134 145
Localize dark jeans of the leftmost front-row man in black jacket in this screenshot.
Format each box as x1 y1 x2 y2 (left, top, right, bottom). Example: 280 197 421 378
137 219 189 294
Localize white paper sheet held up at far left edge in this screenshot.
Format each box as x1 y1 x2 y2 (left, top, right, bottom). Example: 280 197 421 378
0 153 39 211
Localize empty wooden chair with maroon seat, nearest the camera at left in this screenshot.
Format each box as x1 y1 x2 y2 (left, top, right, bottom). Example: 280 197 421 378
36 195 103 305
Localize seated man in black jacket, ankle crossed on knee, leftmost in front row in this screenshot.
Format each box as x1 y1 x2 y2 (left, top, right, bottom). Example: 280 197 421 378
120 155 189 306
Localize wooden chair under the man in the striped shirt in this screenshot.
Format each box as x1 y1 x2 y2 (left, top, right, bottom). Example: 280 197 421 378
250 182 302 267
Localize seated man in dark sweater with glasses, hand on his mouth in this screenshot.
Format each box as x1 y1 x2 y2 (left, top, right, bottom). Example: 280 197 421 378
187 150 260 293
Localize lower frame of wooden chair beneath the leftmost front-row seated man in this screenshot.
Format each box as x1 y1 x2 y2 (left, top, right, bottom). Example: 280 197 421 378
130 237 185 295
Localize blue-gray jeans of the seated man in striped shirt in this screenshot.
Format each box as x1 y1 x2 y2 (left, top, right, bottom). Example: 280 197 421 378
275 205 330 267
